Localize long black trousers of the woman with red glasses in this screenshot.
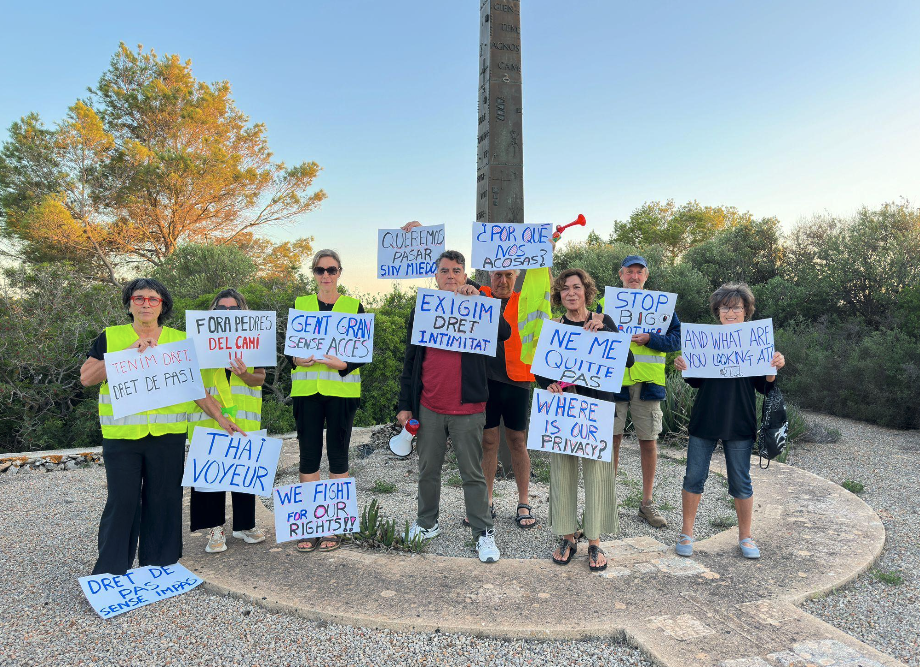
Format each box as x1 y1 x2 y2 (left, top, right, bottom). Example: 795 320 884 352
93 433 185 574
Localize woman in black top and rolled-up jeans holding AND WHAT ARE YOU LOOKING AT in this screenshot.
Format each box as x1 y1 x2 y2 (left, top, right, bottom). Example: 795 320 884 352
674 283 786 558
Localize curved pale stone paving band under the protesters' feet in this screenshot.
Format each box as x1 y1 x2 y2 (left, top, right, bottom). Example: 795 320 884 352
182 456 902 667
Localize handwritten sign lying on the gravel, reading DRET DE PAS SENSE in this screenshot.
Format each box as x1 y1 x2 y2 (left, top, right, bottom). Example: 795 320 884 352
79 563 201 618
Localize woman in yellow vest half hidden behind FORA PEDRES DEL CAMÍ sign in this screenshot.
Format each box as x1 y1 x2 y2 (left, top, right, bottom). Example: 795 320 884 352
188 289 265 553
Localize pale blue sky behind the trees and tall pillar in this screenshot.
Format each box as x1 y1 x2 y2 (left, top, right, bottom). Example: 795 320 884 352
0 0 920 291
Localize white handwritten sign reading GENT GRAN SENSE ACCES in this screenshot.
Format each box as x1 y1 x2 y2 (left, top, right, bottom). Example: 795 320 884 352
284 308 374 363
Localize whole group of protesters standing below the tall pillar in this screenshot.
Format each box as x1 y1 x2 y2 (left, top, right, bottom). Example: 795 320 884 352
81 222 785 574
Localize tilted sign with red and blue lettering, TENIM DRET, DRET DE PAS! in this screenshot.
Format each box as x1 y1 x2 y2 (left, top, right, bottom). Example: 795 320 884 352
105 339 205 419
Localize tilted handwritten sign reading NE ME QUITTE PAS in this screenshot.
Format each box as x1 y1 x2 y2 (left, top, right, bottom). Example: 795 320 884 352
531 320 630 391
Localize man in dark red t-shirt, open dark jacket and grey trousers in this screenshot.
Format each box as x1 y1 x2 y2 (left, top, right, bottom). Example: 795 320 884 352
396 250 511 563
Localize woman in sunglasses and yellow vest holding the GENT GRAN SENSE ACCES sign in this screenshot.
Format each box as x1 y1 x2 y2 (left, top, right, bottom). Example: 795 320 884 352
291 250 364 553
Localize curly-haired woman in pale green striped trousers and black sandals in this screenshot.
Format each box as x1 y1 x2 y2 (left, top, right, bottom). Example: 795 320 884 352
536 269 634 572
